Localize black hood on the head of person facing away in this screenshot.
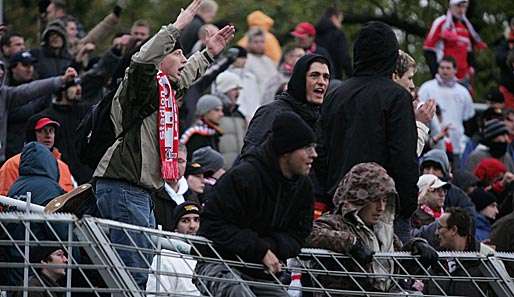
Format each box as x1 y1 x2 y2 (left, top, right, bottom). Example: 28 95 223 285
353 22 400 77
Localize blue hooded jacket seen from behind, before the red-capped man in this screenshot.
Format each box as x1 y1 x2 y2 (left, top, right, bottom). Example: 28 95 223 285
8 142 64 206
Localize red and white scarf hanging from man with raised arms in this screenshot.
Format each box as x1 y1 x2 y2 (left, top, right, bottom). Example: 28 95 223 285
157 71 179 181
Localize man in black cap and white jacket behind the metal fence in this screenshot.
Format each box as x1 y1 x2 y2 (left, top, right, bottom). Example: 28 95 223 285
146 201 202 296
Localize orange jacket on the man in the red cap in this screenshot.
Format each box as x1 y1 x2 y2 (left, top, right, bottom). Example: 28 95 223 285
0 148 73 196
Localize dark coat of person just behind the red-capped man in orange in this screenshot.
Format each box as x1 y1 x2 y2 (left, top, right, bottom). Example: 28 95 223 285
40 103 93 184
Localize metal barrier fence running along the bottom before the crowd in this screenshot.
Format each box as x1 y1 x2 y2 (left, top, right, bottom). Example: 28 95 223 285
0 212 514 297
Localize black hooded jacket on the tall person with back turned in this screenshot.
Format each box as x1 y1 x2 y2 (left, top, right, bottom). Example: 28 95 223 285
315 22 418 217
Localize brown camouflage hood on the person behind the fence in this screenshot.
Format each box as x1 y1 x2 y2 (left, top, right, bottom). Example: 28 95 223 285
332 162 398 222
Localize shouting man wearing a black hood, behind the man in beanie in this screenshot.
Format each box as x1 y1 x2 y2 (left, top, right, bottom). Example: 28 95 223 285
241 54 330 155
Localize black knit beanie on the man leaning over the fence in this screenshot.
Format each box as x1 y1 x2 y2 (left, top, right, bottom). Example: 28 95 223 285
271 112 316 156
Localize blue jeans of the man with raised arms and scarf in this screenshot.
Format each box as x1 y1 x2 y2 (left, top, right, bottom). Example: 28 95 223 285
96 179 155 289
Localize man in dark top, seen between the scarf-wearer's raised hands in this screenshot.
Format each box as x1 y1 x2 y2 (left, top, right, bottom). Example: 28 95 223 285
180 0 218 56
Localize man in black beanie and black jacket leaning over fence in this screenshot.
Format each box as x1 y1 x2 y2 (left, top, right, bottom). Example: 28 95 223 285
195 112 317 297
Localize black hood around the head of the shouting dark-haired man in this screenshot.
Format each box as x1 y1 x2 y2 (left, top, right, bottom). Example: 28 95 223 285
287 54 330 102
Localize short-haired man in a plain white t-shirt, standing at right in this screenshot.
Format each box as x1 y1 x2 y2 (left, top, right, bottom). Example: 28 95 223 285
419 56 475 164
